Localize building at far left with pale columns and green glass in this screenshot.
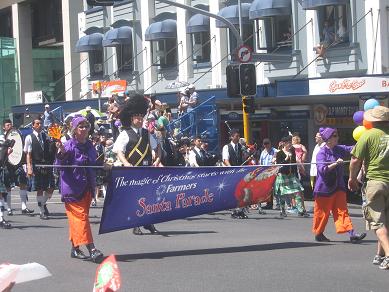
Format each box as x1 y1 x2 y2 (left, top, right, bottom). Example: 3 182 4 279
0 0 83 121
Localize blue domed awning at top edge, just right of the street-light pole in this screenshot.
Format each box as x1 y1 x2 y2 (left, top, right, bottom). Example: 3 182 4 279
249 0 292 20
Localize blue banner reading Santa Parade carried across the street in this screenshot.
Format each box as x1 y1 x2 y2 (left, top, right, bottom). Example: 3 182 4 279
99 166 280 234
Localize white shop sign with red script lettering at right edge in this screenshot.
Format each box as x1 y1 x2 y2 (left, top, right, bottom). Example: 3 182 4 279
309 76 389 95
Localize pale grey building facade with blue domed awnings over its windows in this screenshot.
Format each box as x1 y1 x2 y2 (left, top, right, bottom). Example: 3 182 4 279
76 0 389 149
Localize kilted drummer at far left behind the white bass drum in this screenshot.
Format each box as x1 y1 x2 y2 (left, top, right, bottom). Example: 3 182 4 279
3 119 34 216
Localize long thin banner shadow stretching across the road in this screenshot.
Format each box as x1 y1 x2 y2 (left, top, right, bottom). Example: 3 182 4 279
116 242 330 262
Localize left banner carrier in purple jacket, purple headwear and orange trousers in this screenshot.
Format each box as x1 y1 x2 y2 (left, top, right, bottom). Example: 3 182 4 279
55 116 103 262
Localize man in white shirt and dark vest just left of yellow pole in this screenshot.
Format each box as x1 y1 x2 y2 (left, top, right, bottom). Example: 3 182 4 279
222 129 247 219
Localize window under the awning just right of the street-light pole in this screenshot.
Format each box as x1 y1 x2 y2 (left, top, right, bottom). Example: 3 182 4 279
255 15 292 53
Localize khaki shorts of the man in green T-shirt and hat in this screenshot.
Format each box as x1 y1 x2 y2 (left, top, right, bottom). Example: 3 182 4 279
362 180 389 230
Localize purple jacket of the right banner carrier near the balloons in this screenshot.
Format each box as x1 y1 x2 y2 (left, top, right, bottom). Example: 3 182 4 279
313 145 354 197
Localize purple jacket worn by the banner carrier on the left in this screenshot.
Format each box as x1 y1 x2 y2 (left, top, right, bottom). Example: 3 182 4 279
55 138 97 203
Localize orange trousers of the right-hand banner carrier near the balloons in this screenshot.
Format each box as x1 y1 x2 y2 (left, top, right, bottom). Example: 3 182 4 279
312 191 353 235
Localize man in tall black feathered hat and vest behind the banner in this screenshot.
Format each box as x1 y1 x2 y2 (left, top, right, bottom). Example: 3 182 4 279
113 94 160 235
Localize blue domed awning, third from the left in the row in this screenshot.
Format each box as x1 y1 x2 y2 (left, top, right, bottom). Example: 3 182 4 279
145 19 177 41
